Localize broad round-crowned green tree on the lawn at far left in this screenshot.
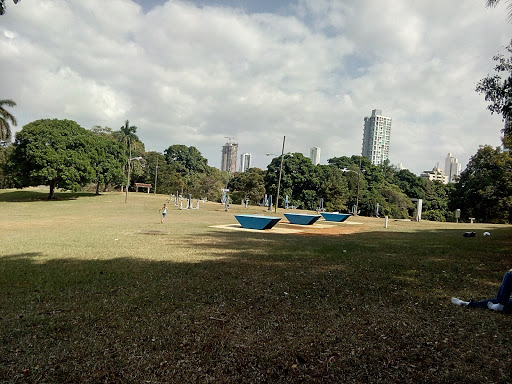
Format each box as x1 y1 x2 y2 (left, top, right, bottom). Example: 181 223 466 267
8 119 95 199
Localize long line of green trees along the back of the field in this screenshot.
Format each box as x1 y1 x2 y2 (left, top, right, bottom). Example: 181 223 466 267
0 119 512 222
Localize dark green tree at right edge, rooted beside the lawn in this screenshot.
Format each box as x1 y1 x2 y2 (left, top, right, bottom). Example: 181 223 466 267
450 145 512 223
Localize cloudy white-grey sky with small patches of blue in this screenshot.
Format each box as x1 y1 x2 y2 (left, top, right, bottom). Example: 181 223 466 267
0 0 512 174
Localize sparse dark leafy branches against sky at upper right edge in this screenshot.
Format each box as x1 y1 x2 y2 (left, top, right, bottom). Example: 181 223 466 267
476 40 512 147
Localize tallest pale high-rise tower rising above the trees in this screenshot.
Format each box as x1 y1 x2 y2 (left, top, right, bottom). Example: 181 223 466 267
362 109 391 165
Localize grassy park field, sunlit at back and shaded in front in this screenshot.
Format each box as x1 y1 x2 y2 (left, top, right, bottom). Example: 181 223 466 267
0 189 512 383
